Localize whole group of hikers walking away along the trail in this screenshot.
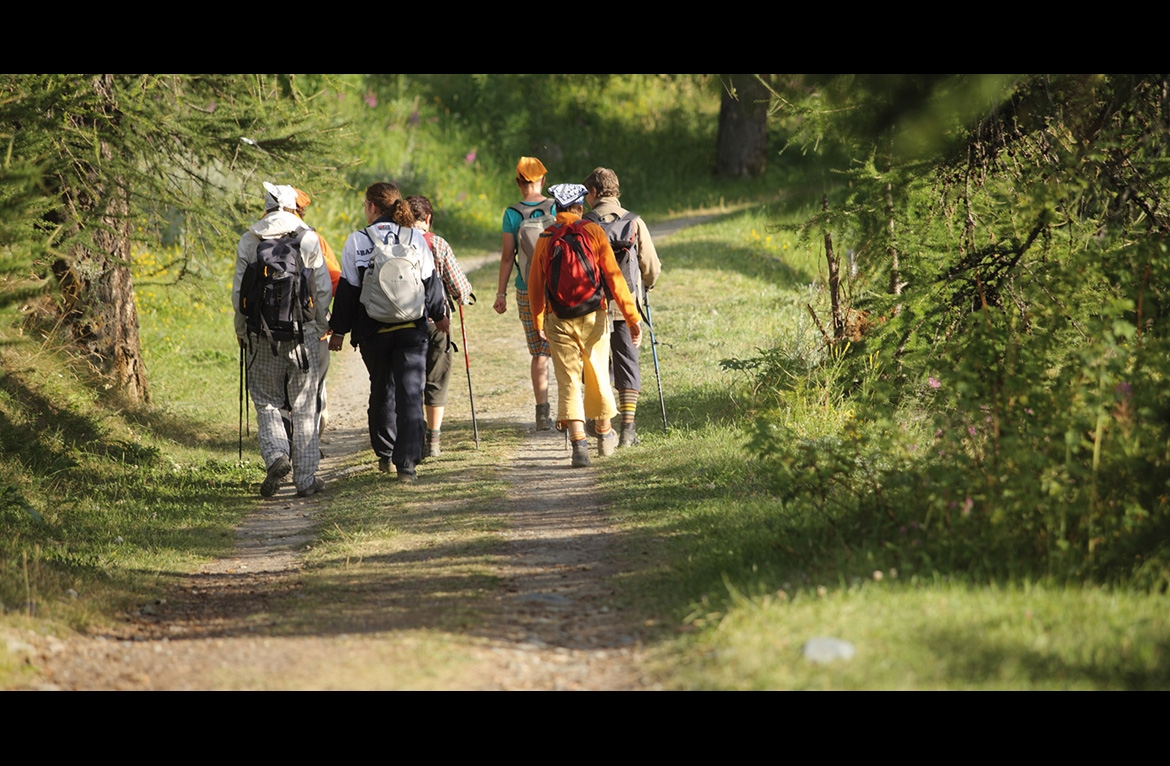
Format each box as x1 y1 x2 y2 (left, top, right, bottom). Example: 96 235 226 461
232 157 661 497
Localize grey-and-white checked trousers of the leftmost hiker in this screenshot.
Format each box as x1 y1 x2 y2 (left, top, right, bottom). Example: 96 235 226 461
248 336 321 490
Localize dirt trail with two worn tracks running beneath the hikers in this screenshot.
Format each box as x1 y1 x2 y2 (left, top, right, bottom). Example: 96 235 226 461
23 216 710 690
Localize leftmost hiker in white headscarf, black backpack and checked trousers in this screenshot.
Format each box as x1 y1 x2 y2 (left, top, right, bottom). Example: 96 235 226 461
232 181 332 497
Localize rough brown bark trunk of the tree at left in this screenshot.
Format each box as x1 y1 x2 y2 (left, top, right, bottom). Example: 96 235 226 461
53 75 150 406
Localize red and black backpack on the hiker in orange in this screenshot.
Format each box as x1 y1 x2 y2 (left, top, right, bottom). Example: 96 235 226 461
541 221 605 319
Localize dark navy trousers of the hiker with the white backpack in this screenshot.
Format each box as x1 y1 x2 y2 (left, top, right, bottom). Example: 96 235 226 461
359 327 427 469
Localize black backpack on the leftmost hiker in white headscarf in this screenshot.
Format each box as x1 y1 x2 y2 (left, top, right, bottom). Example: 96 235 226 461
239 228 316 356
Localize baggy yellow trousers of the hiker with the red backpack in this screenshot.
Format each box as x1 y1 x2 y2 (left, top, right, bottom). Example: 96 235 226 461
544 310 618 422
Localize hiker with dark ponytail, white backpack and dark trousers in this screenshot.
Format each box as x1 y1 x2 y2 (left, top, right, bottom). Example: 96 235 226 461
329 181 450 482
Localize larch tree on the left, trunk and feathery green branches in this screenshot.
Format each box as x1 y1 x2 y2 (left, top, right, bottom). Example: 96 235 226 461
0 75 335 406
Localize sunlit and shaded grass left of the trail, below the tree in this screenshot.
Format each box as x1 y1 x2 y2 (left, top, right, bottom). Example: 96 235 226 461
0 249 259 645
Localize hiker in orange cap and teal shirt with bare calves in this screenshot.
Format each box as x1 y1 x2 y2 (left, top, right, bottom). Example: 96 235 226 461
493 157 553 430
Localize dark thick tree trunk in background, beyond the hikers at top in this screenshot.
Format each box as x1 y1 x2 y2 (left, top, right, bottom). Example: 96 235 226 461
715 75 770 177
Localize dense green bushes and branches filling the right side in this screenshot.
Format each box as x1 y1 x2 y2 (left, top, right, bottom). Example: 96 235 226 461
728 75 1170 589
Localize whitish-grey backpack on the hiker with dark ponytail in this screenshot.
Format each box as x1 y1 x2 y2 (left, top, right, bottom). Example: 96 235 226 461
359 229 431 324
